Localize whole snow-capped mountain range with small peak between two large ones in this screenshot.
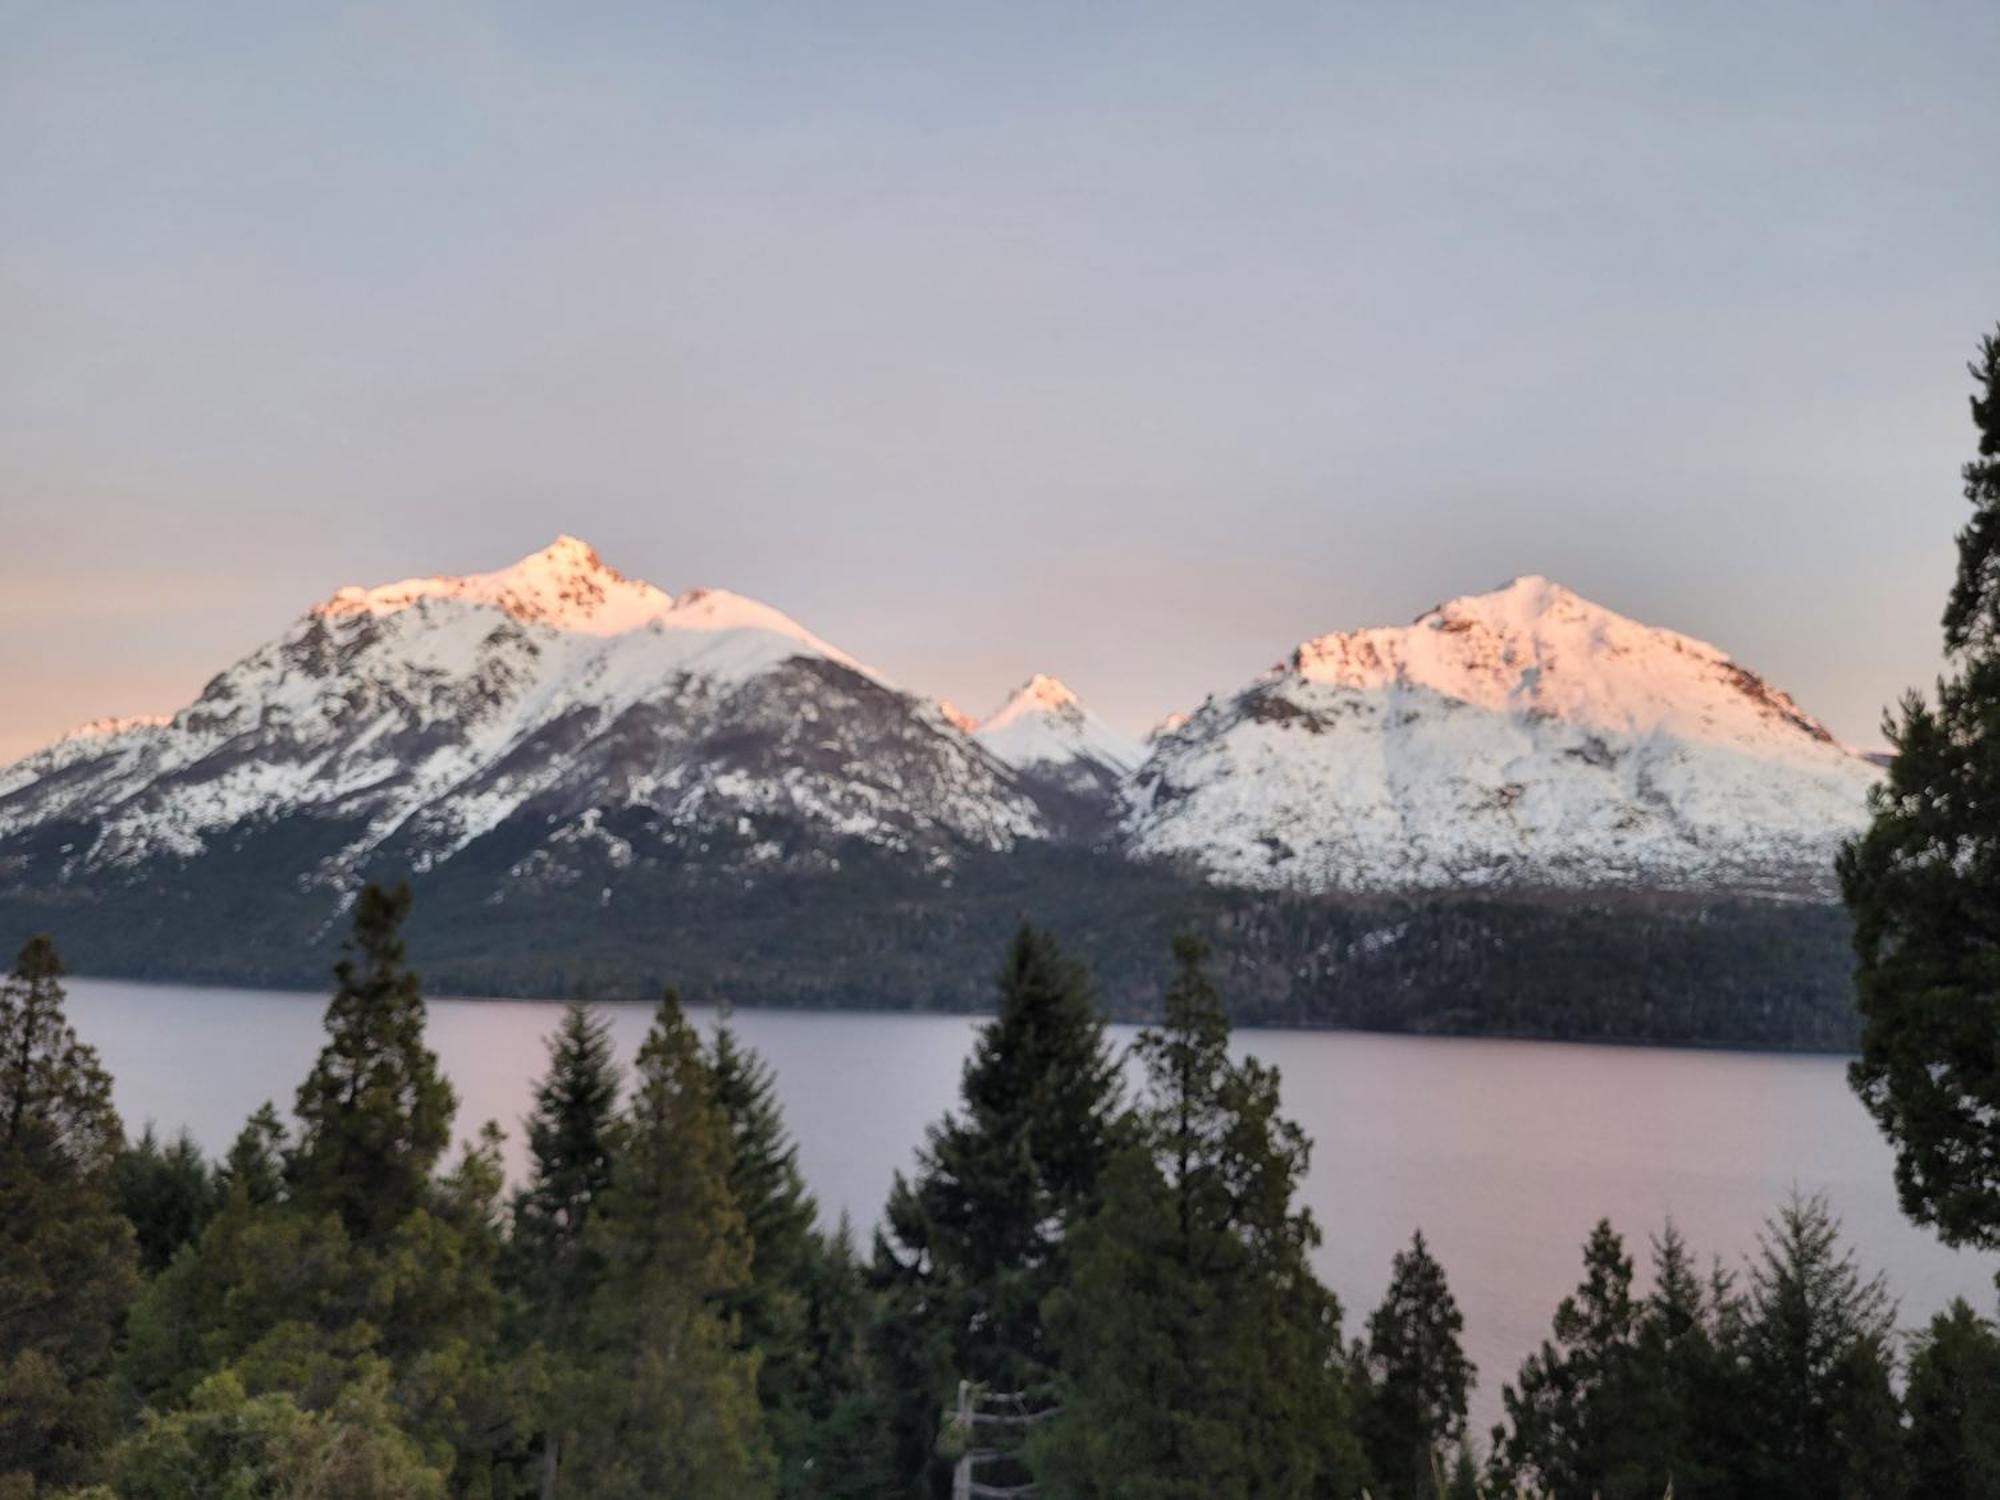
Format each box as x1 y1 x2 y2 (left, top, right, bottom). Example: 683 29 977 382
0 536 1880 1048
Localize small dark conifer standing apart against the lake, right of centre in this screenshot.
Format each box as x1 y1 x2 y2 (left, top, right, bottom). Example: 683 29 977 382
1362 1232 1474 1500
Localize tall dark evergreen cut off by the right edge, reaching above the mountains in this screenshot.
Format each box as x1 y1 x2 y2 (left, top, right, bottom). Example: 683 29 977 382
1840 334 2000 1248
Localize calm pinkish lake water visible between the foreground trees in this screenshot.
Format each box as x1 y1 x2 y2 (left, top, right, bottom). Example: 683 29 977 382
70 980 2000 1432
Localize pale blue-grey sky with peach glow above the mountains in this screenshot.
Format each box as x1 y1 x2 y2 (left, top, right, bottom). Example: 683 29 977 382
0 0 2000 758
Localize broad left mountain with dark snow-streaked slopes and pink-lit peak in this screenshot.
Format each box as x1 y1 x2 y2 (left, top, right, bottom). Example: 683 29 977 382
0 536 1044 888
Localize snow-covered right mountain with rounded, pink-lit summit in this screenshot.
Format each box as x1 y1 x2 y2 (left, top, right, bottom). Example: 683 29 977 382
1124 578 1880 894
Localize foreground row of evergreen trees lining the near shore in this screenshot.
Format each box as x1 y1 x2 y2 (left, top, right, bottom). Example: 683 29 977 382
0 886 2000 1500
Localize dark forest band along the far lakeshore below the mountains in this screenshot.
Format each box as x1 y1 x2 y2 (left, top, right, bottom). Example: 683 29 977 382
0 848 1858 1052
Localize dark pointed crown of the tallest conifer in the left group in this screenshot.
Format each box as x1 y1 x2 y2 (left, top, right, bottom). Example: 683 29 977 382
290 884 456 1242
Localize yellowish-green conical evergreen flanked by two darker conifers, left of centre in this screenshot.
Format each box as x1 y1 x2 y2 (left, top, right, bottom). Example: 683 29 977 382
564 990 774 1500
